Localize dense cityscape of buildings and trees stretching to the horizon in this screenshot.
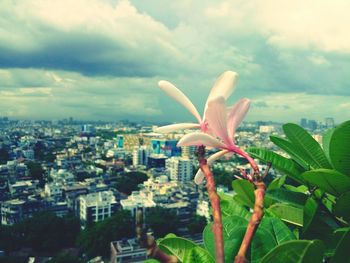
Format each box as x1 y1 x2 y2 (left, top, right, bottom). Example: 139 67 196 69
0 117 335 262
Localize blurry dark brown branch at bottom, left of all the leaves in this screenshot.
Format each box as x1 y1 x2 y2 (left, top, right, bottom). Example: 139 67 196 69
136 209 178 263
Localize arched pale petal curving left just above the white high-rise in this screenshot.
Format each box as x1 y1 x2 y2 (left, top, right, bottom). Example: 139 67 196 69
177 132 227 149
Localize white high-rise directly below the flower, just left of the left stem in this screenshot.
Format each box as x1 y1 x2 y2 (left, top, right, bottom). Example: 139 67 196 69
165 157 193 183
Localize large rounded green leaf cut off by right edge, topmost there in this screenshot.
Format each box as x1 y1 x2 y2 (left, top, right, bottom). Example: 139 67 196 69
328 121 350 176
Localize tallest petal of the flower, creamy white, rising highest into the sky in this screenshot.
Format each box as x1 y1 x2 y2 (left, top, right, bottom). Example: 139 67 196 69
203 71 238 115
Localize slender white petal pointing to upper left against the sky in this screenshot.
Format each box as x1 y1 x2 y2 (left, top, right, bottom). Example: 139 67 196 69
158 80 202 123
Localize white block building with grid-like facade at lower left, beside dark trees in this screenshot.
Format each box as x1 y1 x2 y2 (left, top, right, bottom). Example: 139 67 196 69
79 191 118 227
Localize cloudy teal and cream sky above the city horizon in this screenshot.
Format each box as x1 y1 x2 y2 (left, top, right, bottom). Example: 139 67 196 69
0 0 350 122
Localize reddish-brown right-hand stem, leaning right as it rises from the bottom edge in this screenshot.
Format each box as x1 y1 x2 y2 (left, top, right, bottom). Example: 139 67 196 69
235 181 266 263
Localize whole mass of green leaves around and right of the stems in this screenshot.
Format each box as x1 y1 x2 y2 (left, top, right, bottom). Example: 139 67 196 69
146 121 350 263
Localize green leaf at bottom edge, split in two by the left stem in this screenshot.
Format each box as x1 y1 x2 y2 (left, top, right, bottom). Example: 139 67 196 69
203 216 248 262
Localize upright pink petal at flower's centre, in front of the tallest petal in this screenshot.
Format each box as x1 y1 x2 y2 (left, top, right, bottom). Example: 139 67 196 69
206 97 231 145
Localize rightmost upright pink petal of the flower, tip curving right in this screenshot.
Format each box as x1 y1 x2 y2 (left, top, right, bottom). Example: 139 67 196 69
227 98 250 142
